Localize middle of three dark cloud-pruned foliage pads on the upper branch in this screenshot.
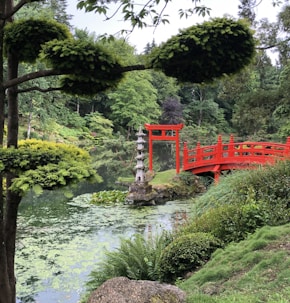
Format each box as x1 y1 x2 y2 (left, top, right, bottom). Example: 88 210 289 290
41 39 123 95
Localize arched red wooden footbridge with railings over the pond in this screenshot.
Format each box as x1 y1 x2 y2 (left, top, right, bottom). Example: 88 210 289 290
183 136 290 181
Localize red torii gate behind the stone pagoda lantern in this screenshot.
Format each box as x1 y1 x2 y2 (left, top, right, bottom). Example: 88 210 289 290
145 123 183 174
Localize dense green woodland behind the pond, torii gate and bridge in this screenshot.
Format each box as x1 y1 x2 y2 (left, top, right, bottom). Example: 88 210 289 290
12 0 290 188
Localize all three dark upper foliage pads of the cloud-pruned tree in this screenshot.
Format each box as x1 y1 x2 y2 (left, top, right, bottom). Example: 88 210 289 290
5 18 255 96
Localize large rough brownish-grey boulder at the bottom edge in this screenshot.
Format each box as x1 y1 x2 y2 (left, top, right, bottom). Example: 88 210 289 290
88 277 186 303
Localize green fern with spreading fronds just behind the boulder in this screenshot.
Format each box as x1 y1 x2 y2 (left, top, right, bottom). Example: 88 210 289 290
87 232 172 290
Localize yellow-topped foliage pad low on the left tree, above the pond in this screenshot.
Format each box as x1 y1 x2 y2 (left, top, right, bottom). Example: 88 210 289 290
0 139 101 195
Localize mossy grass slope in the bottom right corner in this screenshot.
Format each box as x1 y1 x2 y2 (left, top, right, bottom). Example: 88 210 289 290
178 224 290 303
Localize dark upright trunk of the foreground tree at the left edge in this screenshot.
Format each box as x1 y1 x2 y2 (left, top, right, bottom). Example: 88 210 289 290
0 48 21 303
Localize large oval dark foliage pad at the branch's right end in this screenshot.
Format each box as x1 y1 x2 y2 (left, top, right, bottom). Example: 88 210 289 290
149 18 255 83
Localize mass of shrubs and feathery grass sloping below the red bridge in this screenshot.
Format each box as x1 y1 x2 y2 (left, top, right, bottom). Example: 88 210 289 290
185 160 290 243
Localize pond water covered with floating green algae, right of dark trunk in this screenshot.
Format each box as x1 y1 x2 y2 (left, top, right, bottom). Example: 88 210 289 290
15 193 197 303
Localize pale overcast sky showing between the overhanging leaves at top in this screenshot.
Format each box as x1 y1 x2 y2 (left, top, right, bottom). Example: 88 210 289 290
68 0 281 53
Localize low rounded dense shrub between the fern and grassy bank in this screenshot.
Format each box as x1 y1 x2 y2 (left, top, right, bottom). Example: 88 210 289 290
159 232 221 282
